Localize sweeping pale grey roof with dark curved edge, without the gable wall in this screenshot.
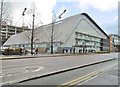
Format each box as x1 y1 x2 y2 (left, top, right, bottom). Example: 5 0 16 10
4 13 108 45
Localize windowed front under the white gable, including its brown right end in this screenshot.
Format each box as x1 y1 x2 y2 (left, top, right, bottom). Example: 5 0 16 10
75 32 109 52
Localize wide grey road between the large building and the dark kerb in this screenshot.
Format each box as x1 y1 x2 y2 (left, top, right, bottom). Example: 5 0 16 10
0 53 118 84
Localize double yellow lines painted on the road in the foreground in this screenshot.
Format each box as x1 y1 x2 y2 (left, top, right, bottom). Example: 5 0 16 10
59 71 101 87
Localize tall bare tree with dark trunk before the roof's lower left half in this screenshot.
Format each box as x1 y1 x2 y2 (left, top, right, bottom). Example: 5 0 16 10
22 2 42 54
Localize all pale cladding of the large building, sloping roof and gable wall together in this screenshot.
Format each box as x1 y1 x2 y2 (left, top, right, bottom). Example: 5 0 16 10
4 14 106 47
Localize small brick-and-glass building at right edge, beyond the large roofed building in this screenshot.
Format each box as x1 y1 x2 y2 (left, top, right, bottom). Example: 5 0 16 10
109 34 120 52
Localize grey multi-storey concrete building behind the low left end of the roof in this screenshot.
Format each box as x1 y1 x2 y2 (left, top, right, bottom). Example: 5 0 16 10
1 24 29 44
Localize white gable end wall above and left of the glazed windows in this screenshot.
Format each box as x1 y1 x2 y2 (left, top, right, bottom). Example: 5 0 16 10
63 15 106 47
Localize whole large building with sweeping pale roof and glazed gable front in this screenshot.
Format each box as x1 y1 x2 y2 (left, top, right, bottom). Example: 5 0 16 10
4 13 109 53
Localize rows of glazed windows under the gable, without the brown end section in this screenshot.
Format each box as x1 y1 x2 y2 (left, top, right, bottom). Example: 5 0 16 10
75 32 101 51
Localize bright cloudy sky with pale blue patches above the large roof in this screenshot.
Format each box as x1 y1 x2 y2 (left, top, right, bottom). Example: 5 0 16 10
9 0 119 34
